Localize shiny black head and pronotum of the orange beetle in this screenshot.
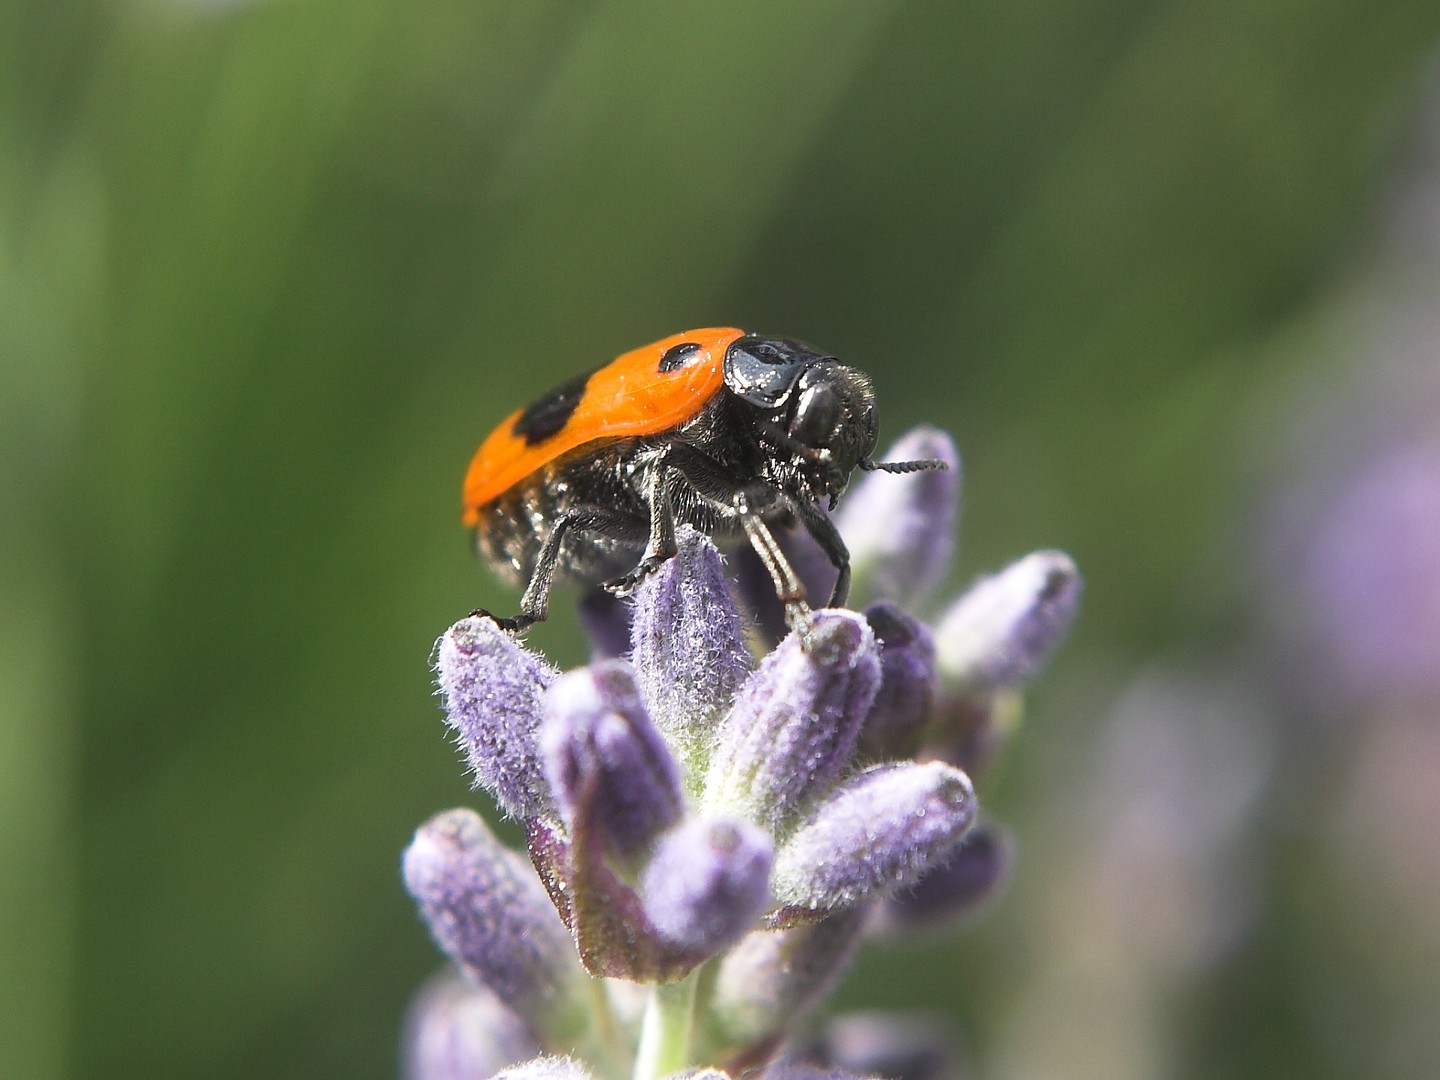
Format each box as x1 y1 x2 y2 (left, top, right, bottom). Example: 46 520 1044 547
724 334 878 504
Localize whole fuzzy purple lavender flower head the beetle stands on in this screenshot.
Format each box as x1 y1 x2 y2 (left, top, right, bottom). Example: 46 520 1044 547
405 429 1079 1080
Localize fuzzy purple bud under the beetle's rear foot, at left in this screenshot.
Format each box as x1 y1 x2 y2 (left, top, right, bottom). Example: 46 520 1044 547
435 616 556 818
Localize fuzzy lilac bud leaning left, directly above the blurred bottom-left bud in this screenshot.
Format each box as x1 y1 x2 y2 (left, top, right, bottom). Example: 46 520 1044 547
403 809 580 1022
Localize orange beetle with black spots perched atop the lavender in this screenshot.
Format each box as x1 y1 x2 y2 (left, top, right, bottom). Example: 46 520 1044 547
461 327 945 632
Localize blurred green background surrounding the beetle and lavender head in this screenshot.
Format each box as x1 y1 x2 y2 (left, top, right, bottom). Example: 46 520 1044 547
8 0 1440 1080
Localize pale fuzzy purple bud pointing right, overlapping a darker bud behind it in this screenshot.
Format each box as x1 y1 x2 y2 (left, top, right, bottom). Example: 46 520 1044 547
775 762 975 910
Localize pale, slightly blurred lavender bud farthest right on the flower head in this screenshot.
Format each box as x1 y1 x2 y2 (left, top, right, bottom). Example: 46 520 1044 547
935 552 1080 694
